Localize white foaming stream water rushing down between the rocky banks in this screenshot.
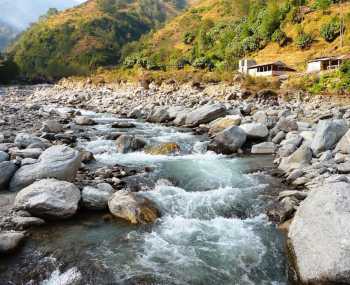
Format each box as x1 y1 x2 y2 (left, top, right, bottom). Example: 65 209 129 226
0 110 287 285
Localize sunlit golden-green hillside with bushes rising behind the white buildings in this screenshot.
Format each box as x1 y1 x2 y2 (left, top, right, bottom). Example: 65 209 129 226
124 0 350 70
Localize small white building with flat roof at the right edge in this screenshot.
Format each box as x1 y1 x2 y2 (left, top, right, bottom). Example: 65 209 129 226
307 55 350 73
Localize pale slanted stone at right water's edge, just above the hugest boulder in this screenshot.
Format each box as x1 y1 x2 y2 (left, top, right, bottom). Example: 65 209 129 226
278 144 312 172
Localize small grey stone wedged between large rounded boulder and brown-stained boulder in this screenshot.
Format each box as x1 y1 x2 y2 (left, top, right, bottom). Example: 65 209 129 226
82 183 115 210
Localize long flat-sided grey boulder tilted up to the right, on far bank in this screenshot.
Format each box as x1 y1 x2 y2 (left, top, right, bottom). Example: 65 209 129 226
186 104 226 127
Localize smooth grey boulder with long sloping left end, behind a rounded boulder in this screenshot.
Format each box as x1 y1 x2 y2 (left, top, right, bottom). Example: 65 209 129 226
10 145 81 191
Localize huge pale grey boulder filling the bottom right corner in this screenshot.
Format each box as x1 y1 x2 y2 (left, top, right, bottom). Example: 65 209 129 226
288 182 350 285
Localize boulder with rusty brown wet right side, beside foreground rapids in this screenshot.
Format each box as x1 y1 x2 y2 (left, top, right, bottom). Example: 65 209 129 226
108 191 160 224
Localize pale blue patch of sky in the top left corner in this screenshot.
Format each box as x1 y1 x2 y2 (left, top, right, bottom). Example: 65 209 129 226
0 0 85 31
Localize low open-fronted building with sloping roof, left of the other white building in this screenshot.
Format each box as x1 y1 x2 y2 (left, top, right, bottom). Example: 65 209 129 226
248 61 296 76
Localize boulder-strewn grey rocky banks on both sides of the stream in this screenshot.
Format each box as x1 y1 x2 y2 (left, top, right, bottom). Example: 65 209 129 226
0 81 350 284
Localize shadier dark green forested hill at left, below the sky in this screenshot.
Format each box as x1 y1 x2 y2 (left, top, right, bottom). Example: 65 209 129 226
10 0 191 79
